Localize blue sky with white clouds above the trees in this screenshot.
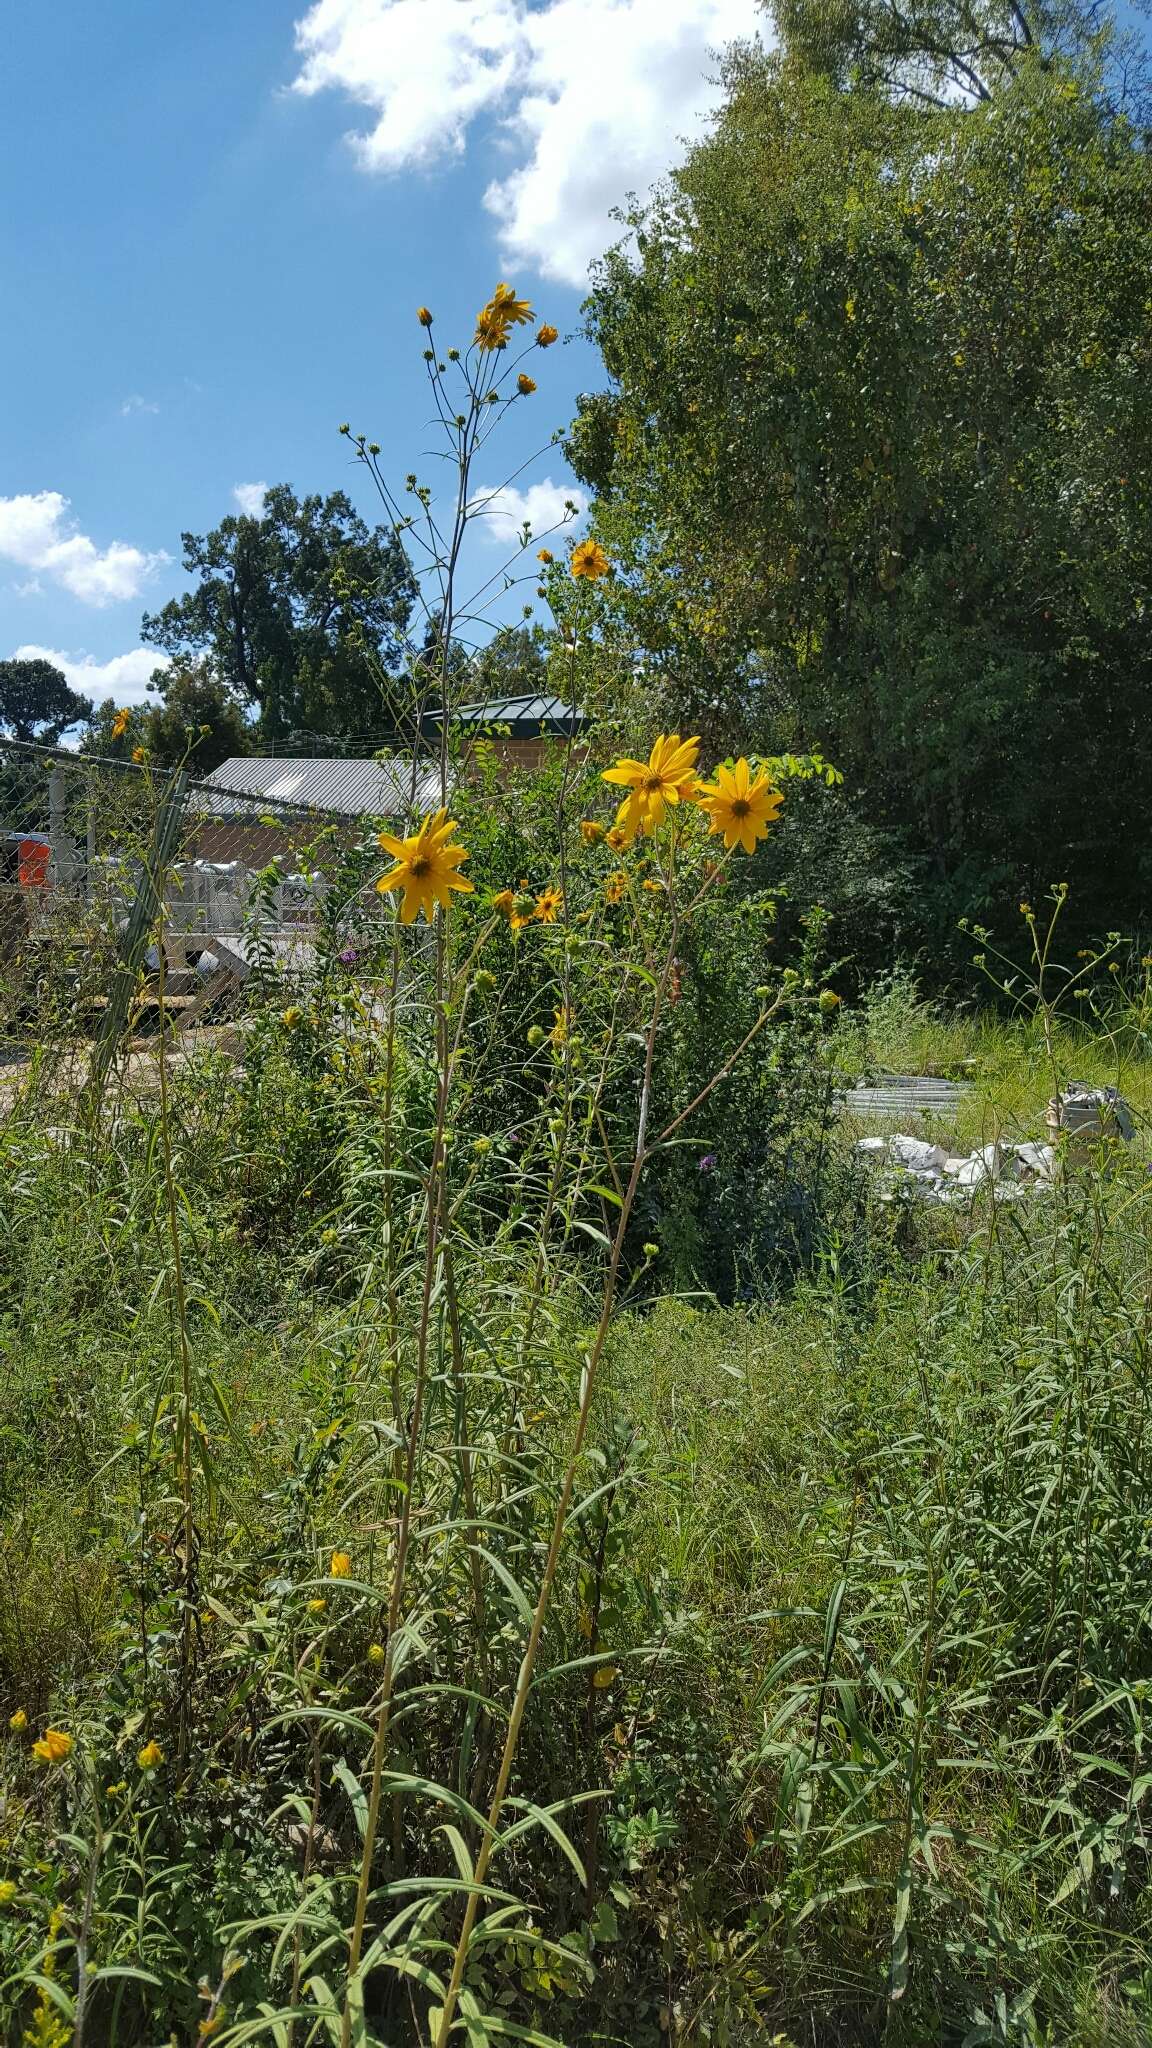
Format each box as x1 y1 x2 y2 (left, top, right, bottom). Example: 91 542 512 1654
0 0 756 702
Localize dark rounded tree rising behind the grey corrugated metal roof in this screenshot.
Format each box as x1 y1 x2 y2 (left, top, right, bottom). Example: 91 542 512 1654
141 483 414 739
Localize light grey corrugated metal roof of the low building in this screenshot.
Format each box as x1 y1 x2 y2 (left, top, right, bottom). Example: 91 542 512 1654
197 756 441 817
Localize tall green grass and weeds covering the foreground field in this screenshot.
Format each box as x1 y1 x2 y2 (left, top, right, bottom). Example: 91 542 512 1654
0 987 1152 2048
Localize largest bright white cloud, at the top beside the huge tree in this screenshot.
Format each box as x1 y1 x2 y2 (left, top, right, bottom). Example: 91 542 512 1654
286 0 763 285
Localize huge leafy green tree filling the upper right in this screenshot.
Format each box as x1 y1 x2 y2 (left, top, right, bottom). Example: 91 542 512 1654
572 9 1152 942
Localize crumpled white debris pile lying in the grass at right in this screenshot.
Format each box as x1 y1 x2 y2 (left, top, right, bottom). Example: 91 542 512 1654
857 1081 1136 1204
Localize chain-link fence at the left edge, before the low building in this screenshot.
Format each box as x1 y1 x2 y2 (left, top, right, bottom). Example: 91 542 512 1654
0 741 400 1108
